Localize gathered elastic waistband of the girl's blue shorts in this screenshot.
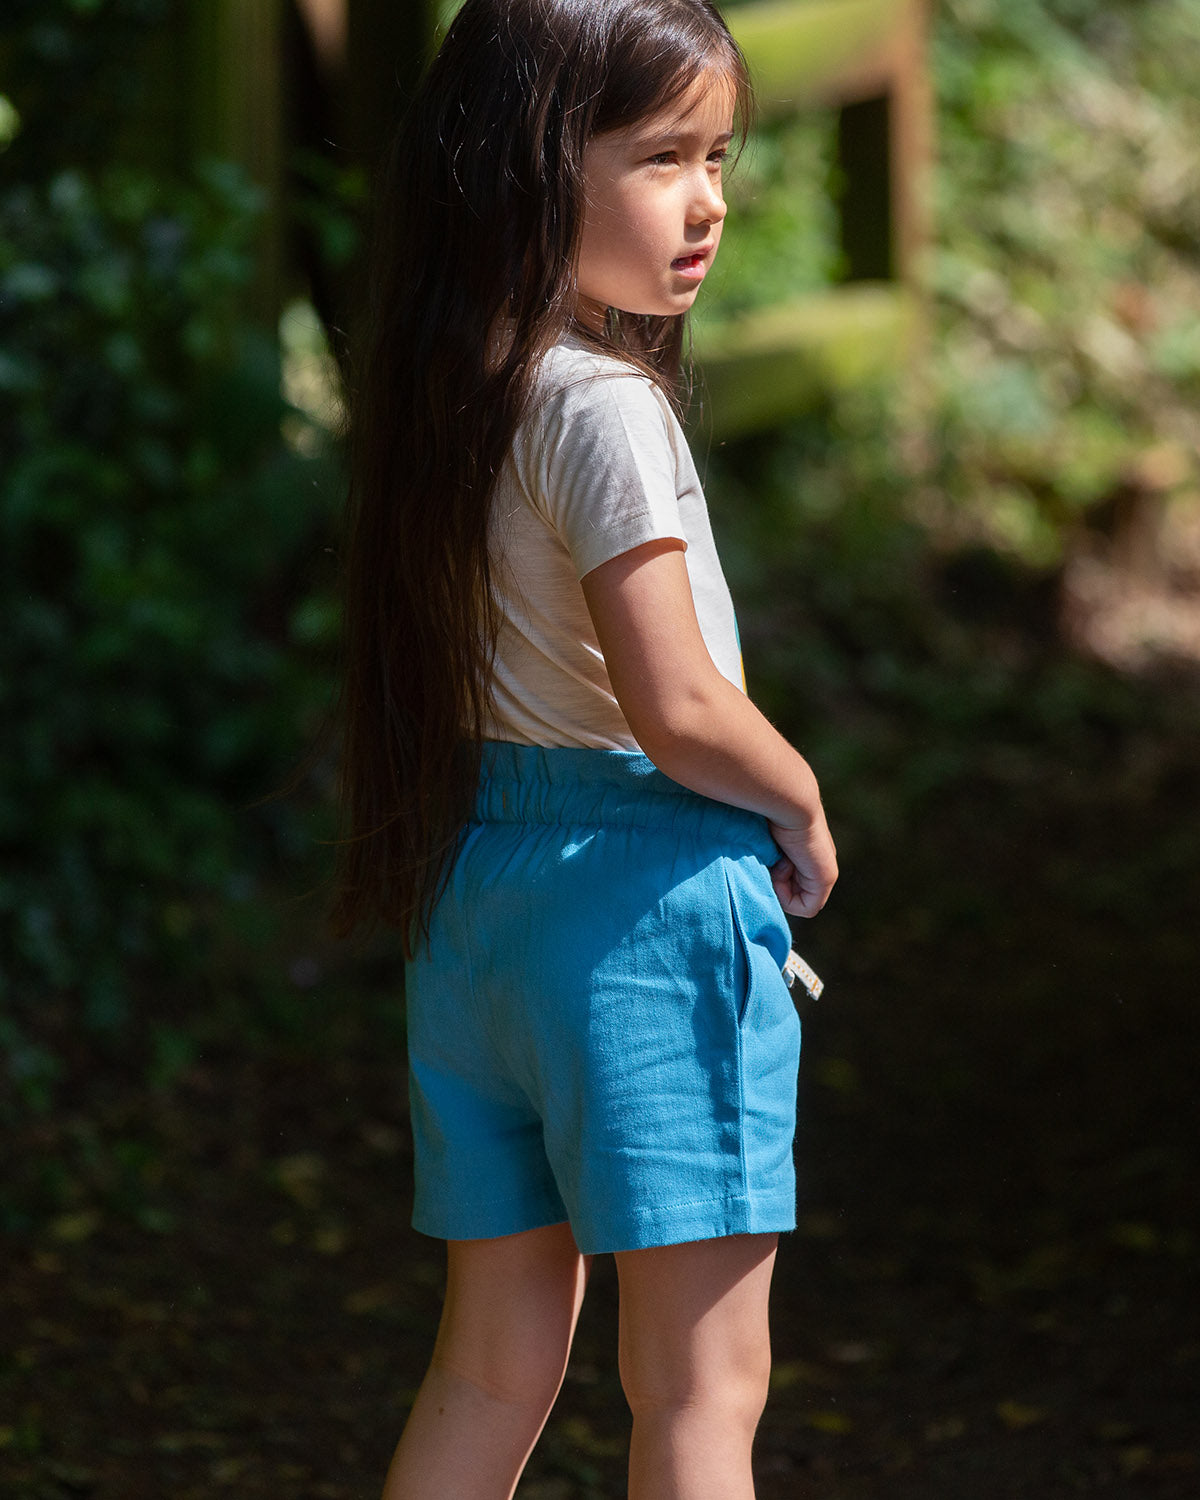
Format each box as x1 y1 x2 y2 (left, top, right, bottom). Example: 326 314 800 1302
474 740 779 864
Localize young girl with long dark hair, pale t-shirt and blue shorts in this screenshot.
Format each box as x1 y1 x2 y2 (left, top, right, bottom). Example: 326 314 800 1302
336 0 837 1500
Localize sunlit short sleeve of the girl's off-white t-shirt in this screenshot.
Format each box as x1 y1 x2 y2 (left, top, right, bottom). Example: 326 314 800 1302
521 371 687 579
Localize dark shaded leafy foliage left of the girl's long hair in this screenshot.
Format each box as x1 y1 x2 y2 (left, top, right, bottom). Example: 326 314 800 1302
0 5 338 1104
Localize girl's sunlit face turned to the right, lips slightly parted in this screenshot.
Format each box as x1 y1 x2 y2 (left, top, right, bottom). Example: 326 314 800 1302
576 72 735 330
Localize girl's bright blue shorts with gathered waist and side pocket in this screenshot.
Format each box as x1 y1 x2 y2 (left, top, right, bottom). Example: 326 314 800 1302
407 743 800 1253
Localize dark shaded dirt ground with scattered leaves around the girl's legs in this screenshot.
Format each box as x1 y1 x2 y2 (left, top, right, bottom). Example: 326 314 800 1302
0 669 1200 1500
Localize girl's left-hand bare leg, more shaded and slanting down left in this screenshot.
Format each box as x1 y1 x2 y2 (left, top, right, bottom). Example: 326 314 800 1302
384 1224 590 1500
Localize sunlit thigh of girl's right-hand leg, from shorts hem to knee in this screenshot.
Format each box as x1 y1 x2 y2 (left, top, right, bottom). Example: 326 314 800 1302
617 1235 779 1406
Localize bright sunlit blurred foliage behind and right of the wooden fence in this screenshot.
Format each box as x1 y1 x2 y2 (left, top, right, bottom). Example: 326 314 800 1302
701 0 1200 570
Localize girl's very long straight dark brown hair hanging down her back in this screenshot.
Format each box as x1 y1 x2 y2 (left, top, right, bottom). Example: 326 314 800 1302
332 0 749 956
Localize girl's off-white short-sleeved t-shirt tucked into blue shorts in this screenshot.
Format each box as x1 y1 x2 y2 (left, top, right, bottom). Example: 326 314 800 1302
486 336 743 750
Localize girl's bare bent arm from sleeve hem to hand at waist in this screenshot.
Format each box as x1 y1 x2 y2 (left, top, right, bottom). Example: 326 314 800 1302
584 539 837 917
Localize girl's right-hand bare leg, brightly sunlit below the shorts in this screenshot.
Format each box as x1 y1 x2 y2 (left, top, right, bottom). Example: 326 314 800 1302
617 1235 777 1500
